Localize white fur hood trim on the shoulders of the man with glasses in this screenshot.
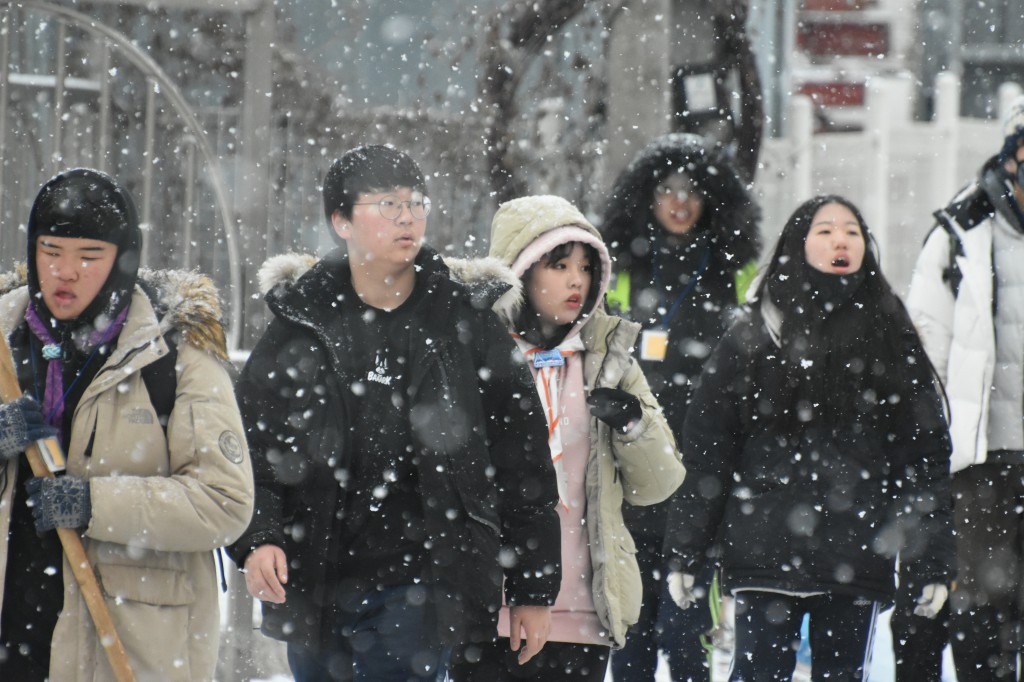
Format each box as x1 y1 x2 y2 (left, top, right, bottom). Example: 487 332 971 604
257 252 522 308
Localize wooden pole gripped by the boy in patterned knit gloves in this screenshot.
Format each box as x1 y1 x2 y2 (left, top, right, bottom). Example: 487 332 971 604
0 332 135 682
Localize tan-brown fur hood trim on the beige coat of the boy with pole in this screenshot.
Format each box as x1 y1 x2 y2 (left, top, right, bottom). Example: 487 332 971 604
0 263 227 360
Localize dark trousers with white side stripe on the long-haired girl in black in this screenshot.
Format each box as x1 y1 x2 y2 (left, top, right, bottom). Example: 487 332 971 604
729 591 879 682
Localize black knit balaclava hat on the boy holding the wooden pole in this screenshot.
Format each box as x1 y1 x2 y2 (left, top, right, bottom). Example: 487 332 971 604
28 168 142 326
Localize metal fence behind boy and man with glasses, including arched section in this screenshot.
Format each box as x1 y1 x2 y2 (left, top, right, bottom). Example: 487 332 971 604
0 0 509 349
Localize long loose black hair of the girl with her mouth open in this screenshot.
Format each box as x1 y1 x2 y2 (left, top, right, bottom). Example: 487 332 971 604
757 195 938 425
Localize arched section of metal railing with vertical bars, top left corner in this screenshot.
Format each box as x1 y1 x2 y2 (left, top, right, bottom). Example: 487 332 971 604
0 1 241 339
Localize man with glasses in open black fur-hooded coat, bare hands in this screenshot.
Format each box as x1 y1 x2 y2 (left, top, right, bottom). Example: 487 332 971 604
231 144 560 682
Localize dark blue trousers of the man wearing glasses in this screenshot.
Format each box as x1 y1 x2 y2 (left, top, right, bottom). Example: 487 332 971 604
288 585 442 682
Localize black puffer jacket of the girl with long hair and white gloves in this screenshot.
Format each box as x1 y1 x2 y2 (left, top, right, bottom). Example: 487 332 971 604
665 303 955 601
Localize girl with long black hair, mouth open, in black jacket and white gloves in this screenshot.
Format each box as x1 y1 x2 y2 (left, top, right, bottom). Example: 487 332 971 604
666 196 953 681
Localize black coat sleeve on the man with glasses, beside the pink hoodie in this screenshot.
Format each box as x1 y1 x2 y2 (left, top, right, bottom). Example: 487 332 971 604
476 311 561 605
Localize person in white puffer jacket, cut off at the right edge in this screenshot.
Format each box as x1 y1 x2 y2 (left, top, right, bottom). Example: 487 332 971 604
892 97 1024 680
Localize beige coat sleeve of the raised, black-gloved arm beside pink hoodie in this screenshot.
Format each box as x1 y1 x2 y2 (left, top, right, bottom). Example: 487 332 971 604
599 357 686 506
